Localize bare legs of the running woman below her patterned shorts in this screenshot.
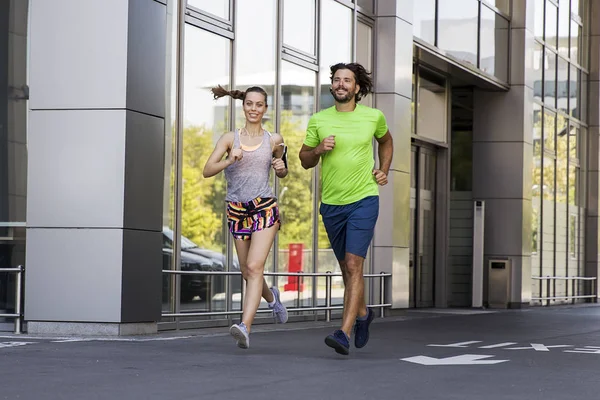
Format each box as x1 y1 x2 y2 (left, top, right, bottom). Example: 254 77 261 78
236 224 279 331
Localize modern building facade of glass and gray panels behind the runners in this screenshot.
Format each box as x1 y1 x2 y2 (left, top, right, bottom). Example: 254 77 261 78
0 0 600 334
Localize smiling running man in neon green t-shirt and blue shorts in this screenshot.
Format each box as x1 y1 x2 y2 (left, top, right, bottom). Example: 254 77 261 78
300 63 394 355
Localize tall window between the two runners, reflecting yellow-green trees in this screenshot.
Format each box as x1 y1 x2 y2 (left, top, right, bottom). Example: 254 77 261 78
277 61 316 304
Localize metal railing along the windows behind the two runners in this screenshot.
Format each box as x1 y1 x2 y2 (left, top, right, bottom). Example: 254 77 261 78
162 269 392 322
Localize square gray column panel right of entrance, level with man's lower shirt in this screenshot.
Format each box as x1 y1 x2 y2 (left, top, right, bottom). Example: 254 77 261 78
473 142 531 199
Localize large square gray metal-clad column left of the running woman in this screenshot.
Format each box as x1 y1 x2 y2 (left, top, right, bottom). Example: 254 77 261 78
25 0 166 334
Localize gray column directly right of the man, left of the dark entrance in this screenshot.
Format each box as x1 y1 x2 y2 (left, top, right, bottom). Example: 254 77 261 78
373 0 413 308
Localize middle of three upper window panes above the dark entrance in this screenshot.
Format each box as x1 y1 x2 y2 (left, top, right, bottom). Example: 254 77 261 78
438 0 479 66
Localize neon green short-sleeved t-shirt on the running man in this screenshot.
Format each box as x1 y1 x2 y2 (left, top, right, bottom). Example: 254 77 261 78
304 104 388 205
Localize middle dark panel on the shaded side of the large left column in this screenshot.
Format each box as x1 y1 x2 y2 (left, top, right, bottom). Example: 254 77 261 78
123 111 165 231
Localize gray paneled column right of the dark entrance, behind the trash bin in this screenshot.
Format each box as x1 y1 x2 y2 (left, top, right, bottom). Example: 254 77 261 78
473 1 534 307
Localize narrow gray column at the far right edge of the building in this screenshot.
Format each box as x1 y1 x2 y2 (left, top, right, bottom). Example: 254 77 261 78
585 1 600 288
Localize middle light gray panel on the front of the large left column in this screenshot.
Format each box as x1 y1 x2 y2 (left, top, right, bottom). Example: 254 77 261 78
27 110 125 228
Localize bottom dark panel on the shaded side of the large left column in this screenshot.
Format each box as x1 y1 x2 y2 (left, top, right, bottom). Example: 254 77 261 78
120 229 162 323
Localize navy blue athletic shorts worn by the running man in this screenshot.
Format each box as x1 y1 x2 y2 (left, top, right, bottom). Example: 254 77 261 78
319 196 379 261
